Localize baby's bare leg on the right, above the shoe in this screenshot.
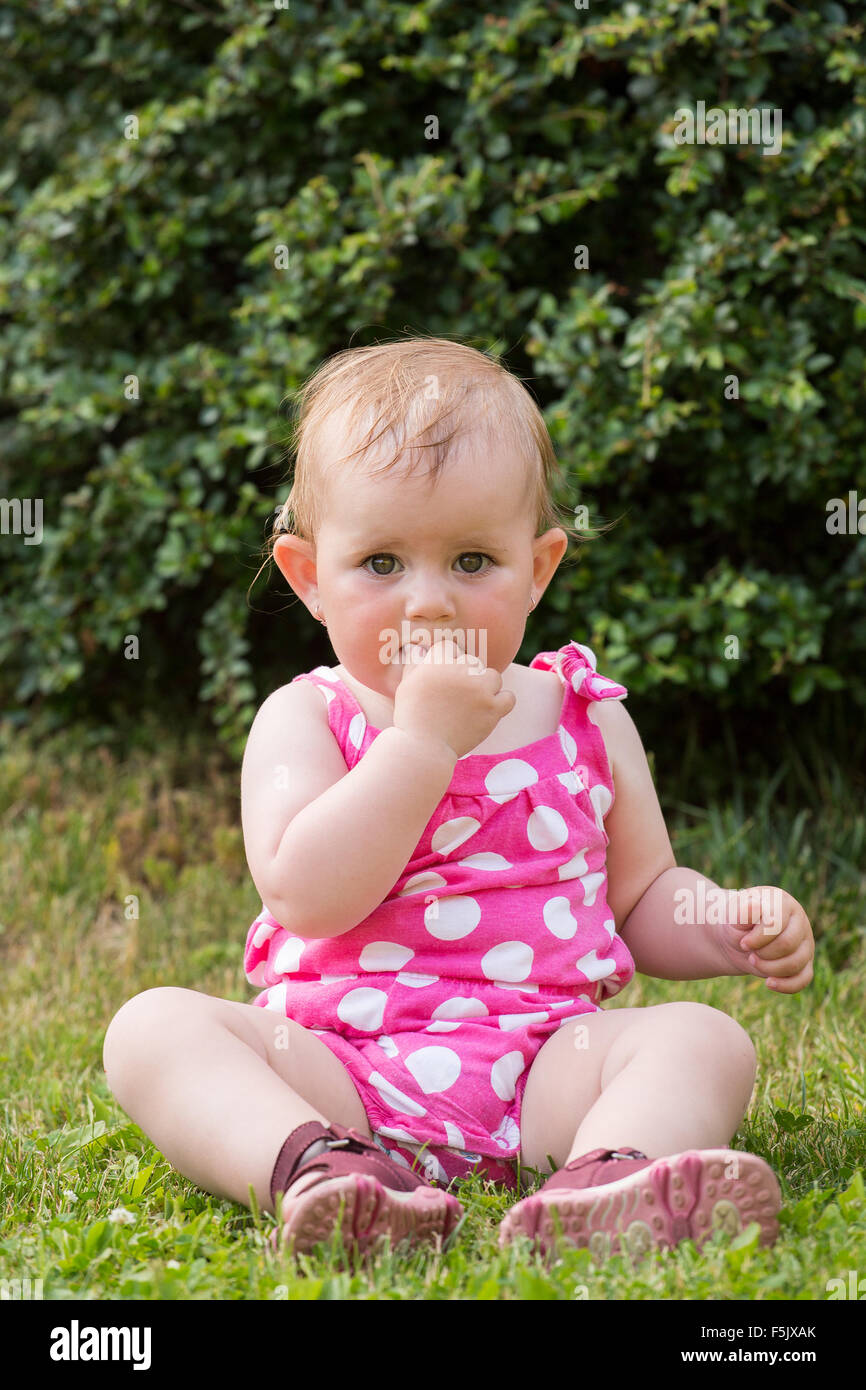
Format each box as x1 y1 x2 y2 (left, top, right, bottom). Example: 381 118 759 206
520 1002 756 1172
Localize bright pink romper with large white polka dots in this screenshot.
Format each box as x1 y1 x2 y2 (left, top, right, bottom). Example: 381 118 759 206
243 642 634 1188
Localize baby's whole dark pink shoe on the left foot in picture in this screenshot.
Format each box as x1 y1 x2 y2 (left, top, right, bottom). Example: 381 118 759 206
270 1120 463 1254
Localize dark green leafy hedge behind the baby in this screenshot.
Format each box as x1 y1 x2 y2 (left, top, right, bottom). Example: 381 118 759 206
0 0 866 755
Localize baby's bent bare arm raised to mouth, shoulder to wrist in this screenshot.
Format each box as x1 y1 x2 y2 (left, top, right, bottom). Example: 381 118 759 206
240 681 457 940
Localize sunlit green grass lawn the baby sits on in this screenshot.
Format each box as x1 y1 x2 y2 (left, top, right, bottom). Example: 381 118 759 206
0 734 866 1300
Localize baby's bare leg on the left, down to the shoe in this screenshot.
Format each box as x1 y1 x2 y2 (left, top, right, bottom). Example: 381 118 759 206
103 987 370 1212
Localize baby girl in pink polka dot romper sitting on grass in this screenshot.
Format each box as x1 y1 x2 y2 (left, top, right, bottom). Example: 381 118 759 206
104 338 815 1255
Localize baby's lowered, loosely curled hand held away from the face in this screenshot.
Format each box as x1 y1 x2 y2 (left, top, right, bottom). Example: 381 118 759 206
720 885 815 994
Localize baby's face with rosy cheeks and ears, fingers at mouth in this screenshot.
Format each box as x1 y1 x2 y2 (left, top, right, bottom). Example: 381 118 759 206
273 411 567 699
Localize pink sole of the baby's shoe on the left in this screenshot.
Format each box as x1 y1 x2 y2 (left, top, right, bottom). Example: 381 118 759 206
271 1173 464 1254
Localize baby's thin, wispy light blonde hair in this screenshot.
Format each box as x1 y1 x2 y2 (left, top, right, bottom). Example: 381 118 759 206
268 336 606 555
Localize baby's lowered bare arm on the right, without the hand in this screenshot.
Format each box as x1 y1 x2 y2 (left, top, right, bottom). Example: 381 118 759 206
591 701 751 980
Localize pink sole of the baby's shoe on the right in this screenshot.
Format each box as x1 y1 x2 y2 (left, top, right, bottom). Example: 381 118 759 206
499 1148 781 1259
